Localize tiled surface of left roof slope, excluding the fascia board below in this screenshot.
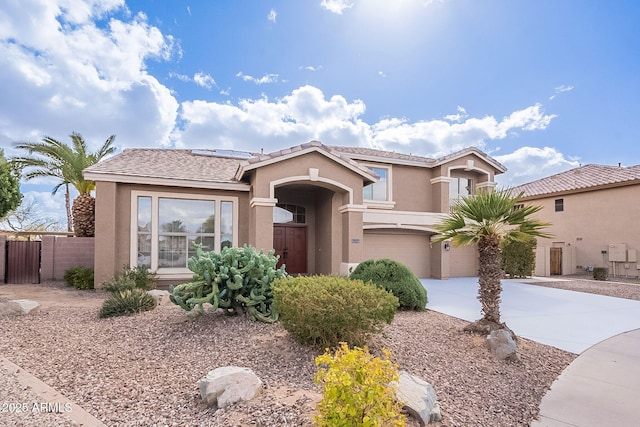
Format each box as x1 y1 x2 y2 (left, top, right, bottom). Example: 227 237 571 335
85 148 245 182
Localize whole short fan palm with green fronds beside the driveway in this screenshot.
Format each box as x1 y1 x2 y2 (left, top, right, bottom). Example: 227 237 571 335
435 190 551 333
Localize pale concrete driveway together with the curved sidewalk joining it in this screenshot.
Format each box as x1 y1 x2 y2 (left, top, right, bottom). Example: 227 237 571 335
421 278 640 427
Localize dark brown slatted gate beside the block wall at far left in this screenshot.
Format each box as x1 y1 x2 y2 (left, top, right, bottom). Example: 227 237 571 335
5 240 42 284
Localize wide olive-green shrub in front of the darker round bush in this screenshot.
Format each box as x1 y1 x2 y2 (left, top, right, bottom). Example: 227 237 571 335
273 276 398 348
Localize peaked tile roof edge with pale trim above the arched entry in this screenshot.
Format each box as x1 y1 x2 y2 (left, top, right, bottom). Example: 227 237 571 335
235 141 379 182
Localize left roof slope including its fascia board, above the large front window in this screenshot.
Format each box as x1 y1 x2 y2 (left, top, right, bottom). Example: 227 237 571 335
84 148 249 191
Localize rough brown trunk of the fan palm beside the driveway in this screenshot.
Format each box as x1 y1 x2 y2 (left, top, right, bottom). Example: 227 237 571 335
478 236 502 324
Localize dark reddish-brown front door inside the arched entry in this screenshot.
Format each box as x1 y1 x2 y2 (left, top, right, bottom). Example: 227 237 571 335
273 225 307 274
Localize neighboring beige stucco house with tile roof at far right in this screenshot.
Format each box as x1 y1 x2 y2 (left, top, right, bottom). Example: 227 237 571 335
513 165 640 277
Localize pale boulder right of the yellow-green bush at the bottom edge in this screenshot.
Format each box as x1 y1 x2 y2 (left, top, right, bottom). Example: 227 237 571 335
396 371 442 425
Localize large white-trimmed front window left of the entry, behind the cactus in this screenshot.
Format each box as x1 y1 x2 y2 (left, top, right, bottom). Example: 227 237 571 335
131 192 238 273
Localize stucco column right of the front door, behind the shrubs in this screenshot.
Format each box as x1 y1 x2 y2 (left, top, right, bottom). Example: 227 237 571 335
338 205 366 275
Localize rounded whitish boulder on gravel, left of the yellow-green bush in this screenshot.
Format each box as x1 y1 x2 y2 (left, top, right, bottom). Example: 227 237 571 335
199 366 262 408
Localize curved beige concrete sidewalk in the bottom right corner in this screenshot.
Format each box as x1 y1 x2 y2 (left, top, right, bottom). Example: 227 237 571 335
531 329 640 427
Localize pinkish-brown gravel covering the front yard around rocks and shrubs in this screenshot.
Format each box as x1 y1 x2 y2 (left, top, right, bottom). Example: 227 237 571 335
0 282 640 427
